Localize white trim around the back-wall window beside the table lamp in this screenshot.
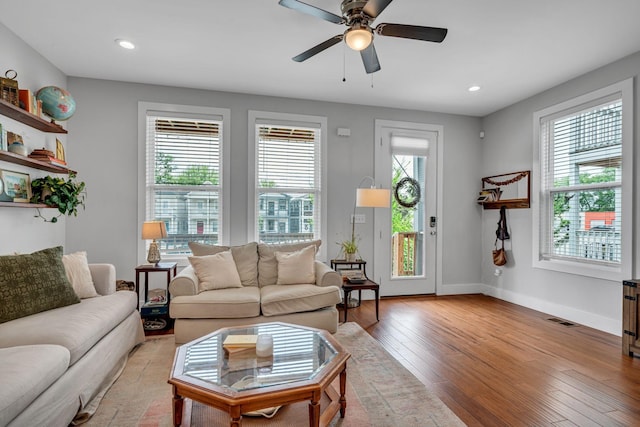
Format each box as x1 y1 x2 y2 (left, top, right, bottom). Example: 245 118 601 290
136 101 231 266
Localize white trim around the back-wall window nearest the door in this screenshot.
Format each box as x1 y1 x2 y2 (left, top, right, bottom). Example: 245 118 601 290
247 110 328 260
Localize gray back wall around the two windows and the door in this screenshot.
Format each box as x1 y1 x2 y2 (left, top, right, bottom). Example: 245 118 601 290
66 77 481 293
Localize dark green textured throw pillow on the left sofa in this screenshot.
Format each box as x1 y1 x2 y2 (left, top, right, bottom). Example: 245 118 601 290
0 246 80 323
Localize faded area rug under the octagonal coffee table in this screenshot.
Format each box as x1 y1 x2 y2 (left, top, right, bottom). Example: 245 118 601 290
85 322 464 427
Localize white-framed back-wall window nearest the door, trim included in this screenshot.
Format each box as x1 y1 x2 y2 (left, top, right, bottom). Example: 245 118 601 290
249 111 326 258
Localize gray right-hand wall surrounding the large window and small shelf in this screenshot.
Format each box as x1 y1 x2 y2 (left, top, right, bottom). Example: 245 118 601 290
482 53 640 335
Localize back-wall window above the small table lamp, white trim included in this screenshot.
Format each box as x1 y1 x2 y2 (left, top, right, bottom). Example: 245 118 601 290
139 102 229 260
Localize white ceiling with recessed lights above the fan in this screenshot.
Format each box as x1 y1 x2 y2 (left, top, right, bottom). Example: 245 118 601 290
0 0 640 116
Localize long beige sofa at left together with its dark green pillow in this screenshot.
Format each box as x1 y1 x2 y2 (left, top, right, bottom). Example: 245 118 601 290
0 247 144 427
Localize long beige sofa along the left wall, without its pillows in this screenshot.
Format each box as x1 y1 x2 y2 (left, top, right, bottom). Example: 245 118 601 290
0 249 144 427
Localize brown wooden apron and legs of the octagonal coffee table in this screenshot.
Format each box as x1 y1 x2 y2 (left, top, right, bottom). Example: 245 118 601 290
172 359 347 427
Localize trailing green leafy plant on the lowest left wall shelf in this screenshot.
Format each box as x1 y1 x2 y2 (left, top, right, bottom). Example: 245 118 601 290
31 172 85 222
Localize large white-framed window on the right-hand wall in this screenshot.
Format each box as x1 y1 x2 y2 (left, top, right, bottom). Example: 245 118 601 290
534 82 633 280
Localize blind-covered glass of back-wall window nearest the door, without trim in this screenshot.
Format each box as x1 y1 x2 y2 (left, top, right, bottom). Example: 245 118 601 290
255 121 322 243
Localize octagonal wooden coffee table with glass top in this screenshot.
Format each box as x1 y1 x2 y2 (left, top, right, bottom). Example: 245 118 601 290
169 322 351 427
